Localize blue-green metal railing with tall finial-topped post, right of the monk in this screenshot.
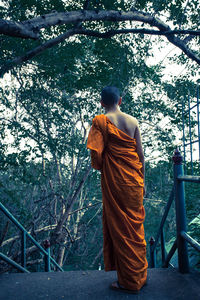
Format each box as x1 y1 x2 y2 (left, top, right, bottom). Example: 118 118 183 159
149 149 200 273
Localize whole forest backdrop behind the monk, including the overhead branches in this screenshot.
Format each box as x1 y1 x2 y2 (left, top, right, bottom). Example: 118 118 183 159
0 0 200 272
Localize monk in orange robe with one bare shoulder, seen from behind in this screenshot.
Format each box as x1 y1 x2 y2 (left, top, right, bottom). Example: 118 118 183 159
87 86 147 293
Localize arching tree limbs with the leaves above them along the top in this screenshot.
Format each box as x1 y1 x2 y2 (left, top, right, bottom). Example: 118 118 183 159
0 0 200 74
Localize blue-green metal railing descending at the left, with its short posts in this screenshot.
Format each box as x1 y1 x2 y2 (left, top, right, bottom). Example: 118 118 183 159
0 202 64 273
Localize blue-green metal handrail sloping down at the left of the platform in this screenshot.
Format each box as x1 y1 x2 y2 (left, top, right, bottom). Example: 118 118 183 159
0 202 64 272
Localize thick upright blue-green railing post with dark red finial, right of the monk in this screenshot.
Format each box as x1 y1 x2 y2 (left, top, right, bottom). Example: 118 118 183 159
173 149 189 273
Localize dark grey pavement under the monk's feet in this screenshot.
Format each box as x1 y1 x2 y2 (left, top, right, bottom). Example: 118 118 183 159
0 269 200 300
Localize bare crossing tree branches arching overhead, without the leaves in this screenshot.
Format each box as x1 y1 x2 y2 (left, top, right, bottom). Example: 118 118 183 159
0 10 200 76
